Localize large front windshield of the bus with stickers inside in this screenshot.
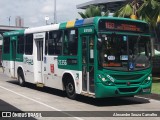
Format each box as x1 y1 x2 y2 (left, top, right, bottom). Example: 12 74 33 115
99 34 151 71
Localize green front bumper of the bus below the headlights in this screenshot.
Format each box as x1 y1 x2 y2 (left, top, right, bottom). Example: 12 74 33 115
95 81 152 98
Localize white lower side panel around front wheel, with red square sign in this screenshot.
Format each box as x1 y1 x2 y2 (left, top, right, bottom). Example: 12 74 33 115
43 56 82 94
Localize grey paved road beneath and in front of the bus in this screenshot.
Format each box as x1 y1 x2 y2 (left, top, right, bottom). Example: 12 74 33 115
0 70 160 120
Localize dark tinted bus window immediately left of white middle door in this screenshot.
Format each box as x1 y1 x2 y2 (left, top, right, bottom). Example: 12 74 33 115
25 34 33 55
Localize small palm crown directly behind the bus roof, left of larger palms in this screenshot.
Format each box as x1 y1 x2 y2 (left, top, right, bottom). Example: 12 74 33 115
78 5 109 18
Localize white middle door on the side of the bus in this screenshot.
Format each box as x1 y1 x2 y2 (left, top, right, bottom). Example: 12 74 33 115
33 33 45 84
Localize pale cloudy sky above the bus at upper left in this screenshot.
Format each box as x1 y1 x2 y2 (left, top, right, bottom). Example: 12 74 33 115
0 0 91 27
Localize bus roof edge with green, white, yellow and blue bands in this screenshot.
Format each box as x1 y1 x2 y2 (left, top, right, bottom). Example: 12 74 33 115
3 17 147 36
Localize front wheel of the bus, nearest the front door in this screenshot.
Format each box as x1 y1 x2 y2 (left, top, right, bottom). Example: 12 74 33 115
65 78 76 100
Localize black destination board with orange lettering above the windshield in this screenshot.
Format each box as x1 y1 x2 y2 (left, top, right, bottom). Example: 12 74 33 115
98 19 149 34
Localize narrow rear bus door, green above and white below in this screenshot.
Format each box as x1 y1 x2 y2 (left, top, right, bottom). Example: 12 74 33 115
10 36 17 78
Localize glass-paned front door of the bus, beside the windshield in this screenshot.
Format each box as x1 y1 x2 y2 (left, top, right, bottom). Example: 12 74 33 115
81 35 94 93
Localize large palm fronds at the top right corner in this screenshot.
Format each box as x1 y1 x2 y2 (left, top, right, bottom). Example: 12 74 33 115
114 0 160 28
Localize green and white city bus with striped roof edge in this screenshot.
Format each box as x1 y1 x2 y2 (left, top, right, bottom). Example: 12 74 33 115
2 17 152 99
